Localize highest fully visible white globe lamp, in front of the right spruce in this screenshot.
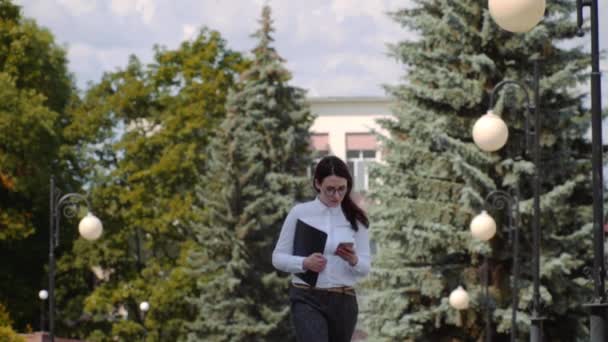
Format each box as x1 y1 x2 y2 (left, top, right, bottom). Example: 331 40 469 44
473 111 509 152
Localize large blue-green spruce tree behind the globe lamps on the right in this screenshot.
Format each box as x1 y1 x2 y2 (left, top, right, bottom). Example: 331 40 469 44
363 0 592 341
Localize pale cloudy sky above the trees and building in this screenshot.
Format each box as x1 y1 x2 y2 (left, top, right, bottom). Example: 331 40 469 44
11 0 608 99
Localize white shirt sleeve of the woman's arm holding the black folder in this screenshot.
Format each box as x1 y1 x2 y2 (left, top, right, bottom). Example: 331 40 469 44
272 207 305 273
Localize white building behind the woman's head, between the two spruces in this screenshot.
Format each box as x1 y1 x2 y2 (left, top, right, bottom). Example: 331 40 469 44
308 97 392 193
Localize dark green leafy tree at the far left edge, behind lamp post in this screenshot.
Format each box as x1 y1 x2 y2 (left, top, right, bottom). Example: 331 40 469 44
0 0 82 329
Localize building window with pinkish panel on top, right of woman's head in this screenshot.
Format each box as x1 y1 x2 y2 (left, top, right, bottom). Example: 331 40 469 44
346 133 377 193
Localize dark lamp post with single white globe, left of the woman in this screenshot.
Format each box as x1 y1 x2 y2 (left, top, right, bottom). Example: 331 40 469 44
48 177 103 342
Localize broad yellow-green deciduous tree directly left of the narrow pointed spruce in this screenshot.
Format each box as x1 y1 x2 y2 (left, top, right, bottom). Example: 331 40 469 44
58 29 247 341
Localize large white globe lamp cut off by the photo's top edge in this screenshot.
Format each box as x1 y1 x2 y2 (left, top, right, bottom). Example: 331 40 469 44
488 0 546 33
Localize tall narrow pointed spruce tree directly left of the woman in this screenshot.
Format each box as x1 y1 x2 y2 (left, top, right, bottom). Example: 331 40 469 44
189 6 312 341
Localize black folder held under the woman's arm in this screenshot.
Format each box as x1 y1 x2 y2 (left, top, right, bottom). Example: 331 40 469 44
293 220 327 287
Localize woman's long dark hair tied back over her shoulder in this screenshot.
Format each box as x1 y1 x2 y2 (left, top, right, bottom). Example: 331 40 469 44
312 156 369 231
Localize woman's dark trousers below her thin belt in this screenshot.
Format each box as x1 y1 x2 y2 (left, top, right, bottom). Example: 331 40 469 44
289 287 359 342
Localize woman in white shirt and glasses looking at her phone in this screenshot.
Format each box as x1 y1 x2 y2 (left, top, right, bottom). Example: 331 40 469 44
272 156 371 342
